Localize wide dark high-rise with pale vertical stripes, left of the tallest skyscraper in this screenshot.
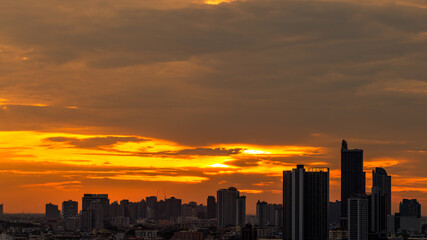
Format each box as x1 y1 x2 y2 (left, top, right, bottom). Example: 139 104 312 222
283 165 329 240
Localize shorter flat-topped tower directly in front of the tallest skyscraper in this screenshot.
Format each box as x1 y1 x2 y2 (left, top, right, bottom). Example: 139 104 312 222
347 195 369 240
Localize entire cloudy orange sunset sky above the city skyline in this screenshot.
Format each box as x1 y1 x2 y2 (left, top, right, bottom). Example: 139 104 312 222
0 0 427 215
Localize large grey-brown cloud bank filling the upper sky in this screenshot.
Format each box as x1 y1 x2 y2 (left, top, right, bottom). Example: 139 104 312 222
0 0 427 213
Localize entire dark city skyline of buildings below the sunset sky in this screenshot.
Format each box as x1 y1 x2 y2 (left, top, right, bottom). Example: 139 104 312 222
0 140 427 240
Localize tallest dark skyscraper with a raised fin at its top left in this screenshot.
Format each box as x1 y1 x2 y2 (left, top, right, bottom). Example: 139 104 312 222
341 140 365 226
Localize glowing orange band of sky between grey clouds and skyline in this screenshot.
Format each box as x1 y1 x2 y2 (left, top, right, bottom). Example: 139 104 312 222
0 131 427 212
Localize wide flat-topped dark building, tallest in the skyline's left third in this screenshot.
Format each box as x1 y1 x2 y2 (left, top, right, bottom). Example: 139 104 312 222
82 194 110 231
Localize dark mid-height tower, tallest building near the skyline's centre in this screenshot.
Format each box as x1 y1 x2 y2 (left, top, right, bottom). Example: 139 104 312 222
217 187 242 227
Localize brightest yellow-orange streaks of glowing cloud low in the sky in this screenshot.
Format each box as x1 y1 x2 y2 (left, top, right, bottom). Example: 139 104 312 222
0 131 323 183
